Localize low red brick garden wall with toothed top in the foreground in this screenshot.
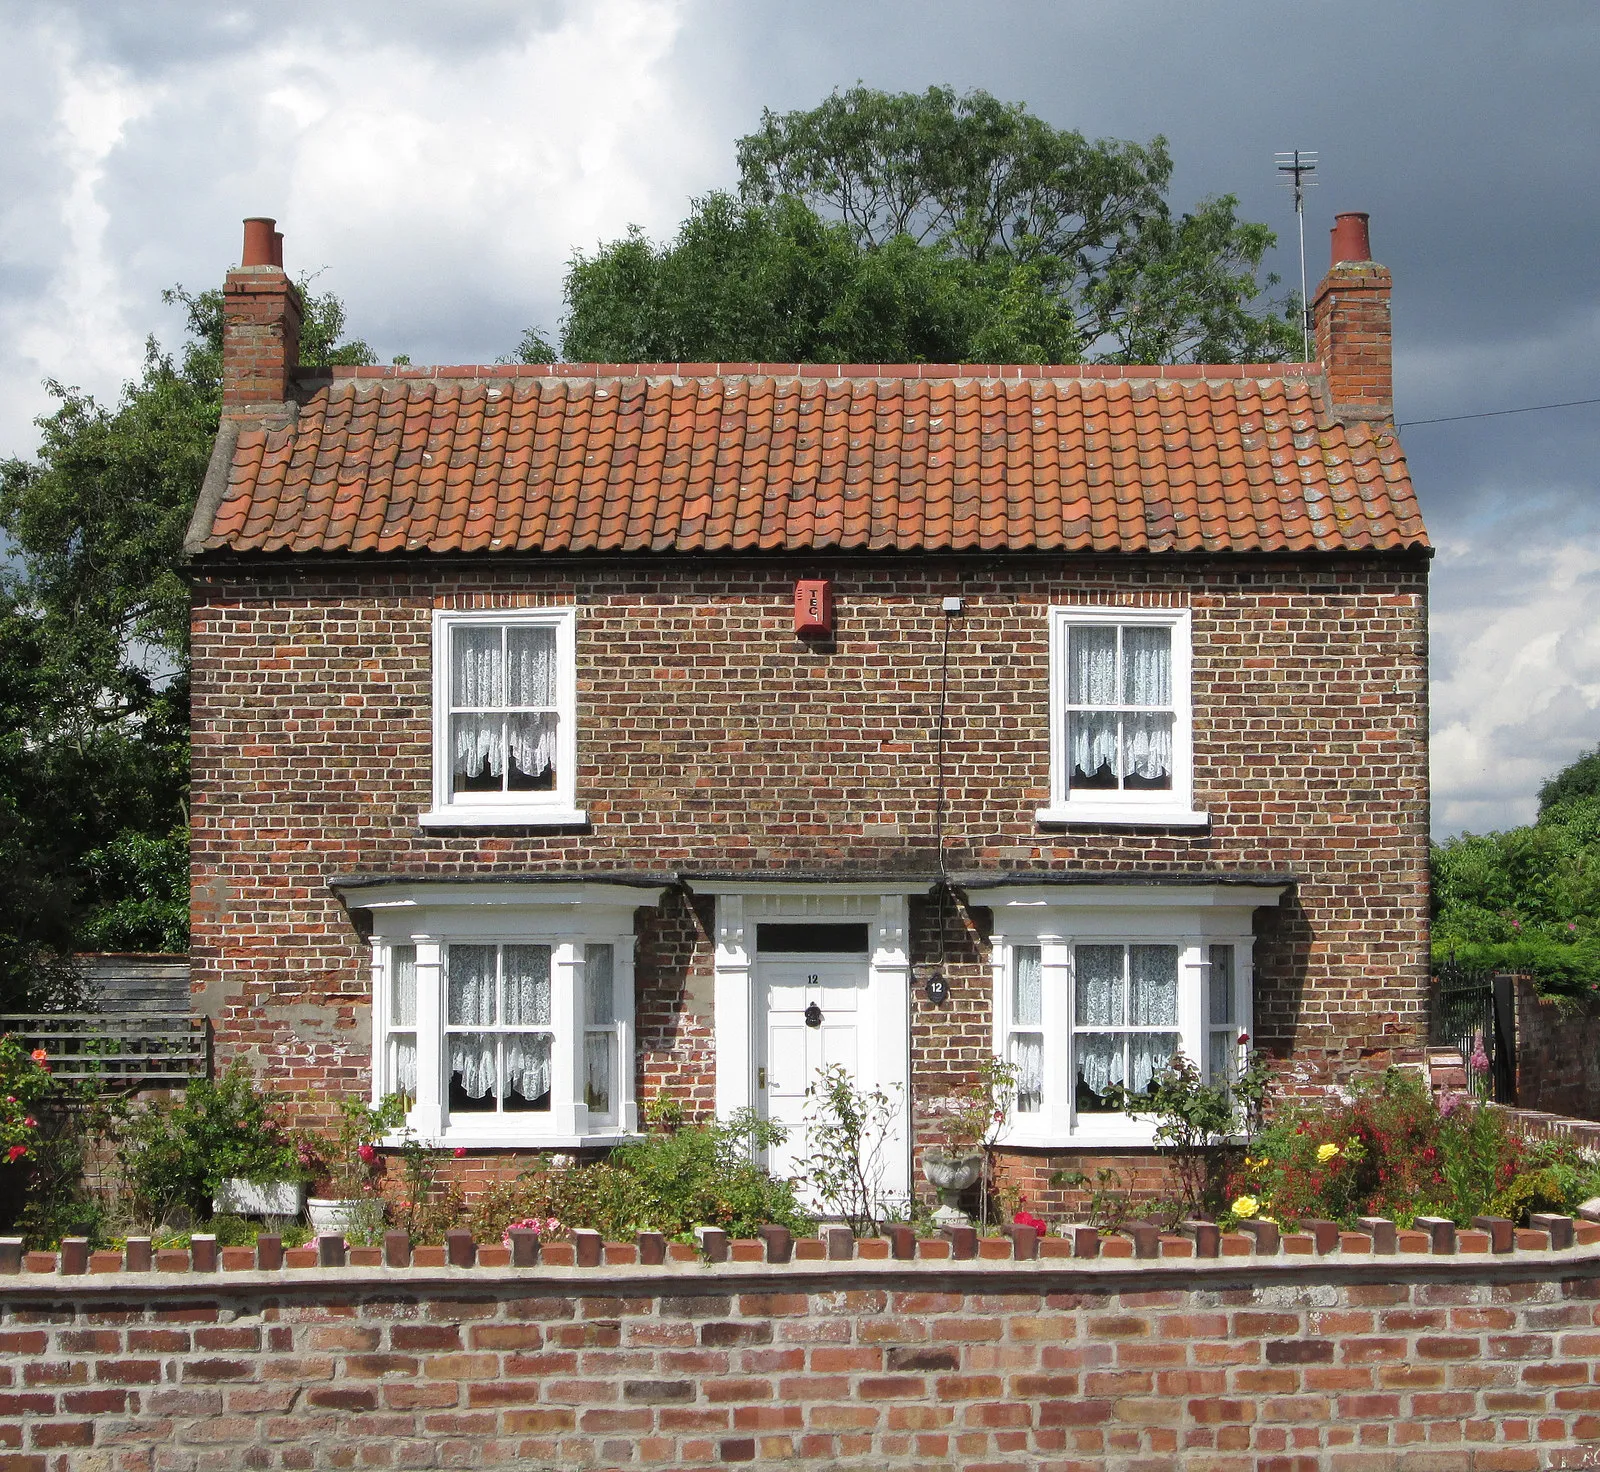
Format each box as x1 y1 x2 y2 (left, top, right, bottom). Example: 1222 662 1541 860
9 1219 1600 1472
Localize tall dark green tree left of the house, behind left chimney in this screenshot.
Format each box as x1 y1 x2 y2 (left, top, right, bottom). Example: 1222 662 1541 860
0 288 374 1008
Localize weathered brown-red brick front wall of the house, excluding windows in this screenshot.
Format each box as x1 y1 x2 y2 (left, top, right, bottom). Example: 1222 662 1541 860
192 557 1427 1152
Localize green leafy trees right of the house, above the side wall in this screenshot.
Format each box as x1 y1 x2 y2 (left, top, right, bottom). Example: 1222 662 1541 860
1432 752 1600 995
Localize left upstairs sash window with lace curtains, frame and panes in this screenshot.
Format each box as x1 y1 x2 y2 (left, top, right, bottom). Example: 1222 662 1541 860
422 608 584 826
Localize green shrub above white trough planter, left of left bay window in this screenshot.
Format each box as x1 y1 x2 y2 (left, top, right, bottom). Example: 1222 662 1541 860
117 1062 301 1221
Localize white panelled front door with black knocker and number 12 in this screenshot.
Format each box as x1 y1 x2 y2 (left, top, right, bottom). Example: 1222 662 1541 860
757 955 877 1205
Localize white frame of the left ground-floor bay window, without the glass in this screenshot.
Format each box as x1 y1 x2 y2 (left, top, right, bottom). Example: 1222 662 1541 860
356 882 661 1149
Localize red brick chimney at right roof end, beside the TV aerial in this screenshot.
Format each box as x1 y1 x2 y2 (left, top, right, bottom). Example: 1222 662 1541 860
1312 213 1395 422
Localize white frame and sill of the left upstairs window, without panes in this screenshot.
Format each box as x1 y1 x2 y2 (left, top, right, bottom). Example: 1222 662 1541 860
421 608 589 827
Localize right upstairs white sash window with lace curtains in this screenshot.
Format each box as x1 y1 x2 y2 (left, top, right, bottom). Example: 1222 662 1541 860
1038 608 1205 827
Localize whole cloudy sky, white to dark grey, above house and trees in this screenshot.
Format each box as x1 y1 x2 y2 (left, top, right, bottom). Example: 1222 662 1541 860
0 0 1600 835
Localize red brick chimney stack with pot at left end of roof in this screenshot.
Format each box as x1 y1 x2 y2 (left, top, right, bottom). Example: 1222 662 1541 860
222 218 304 424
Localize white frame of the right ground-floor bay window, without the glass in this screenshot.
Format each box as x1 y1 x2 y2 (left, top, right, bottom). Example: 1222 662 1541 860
968 885 1283 1149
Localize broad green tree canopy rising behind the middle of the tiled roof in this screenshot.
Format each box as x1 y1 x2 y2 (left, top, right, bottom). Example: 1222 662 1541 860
537 86 1301 363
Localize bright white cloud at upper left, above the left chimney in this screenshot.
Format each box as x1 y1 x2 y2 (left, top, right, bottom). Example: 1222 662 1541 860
0 0 713 453
